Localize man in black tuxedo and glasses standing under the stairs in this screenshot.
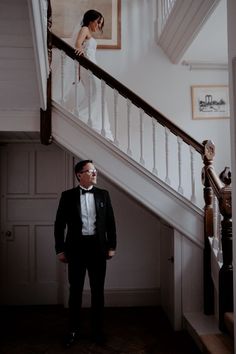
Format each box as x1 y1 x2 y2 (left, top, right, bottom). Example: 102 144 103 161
54 160 116 347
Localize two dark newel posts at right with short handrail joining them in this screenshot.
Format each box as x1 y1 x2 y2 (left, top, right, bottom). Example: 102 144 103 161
202 141 233 331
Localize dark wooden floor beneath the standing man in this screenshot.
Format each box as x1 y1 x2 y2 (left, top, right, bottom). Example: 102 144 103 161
0 306 203 354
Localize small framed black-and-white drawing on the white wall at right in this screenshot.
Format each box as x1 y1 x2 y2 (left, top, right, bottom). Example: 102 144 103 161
191 85 230 119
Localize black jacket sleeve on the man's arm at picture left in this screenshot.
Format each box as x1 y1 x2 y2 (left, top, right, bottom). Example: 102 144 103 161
54 192 66 254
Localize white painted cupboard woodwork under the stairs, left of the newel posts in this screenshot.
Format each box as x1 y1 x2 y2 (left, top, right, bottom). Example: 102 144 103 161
160 222 200 330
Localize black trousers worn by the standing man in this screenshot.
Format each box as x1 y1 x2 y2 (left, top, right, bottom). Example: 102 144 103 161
68 236 106 334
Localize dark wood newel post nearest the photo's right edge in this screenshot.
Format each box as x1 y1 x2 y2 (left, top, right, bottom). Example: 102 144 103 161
219 167 233 331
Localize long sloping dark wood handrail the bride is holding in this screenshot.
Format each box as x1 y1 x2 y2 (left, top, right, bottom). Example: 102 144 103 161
51 32 204 156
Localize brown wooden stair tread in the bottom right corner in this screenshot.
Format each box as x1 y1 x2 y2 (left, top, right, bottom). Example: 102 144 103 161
200 333 234 354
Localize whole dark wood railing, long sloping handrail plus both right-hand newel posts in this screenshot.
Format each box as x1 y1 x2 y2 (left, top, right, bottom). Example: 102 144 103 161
47 33 233 328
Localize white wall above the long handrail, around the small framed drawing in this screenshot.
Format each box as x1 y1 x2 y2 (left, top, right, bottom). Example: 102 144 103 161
97 0 230 172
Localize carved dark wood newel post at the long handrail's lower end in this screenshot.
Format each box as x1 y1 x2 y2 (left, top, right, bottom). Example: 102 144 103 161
202 140 215 315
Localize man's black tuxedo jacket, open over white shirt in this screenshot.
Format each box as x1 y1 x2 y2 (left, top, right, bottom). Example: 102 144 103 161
54 187 116 257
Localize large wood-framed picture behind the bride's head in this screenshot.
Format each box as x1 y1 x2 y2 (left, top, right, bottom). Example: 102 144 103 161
51 0 121 49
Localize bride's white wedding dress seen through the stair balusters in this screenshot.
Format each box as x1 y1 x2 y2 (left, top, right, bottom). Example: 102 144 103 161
56 32 114 140
